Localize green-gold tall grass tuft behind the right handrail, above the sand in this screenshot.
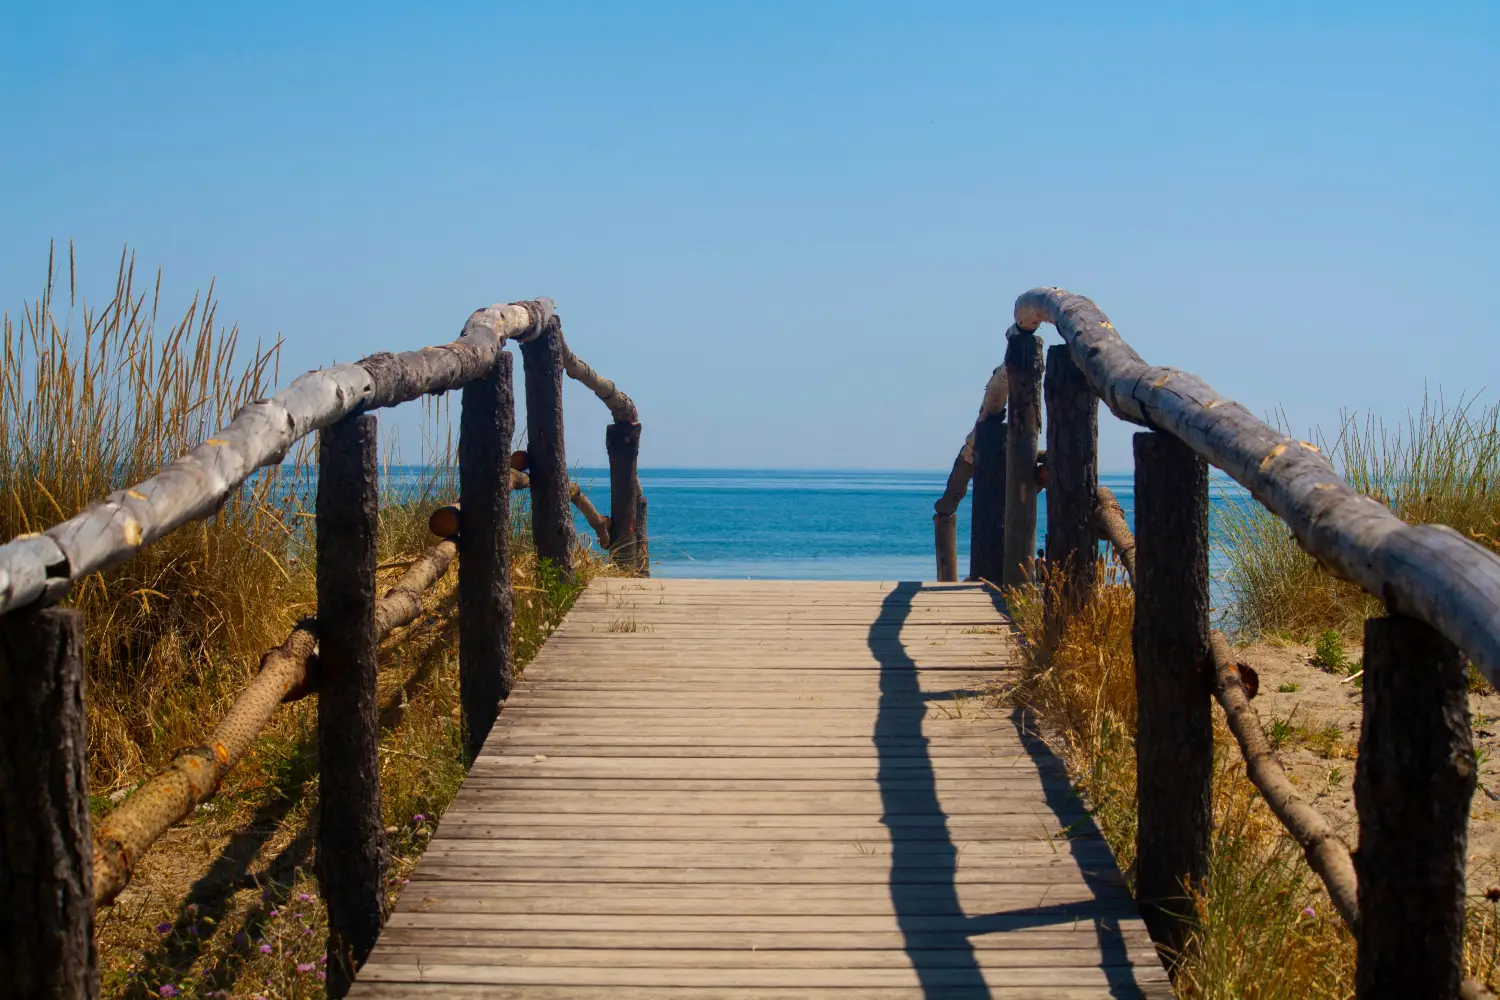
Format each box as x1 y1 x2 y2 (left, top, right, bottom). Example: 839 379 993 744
1218 396 1500 642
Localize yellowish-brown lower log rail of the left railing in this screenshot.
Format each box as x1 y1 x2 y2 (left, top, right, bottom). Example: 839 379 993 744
93 539 458 906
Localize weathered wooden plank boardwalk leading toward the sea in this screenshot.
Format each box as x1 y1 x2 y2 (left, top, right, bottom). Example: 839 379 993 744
351 580 1172 1000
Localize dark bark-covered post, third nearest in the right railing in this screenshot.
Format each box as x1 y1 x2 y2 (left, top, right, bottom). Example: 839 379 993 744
1043 343 1100 627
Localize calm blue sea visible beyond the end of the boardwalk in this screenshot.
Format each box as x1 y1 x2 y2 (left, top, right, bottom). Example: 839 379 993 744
575 469 1233 599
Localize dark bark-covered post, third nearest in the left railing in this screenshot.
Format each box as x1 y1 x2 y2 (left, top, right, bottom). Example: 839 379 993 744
459 352 516 760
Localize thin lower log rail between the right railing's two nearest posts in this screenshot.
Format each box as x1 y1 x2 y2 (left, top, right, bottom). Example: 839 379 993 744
1211 633 1359 934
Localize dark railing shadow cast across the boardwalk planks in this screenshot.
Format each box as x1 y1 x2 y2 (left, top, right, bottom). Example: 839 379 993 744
869 583 1145 1000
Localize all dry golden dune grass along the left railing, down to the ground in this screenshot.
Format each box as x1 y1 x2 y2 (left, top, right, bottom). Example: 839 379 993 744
0 248 609 997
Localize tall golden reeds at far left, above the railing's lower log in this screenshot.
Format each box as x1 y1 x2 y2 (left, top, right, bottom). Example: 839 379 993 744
0 247 311 787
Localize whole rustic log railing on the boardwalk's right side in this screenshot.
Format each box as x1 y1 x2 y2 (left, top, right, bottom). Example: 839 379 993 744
935 288 1500 1000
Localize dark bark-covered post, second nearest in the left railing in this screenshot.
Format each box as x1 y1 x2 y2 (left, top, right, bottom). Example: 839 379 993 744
317 414 390 997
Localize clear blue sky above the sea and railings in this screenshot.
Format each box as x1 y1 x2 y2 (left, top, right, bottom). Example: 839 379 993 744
0 0 1500 468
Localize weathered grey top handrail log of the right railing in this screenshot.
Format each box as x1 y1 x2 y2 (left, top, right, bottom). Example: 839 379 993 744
1016 288 1500 684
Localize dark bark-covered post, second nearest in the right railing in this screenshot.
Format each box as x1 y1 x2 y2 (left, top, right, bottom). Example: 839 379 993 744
1133 433 1214 954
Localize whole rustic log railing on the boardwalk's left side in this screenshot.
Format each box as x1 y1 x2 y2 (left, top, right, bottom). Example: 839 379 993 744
0 298 648 1000
